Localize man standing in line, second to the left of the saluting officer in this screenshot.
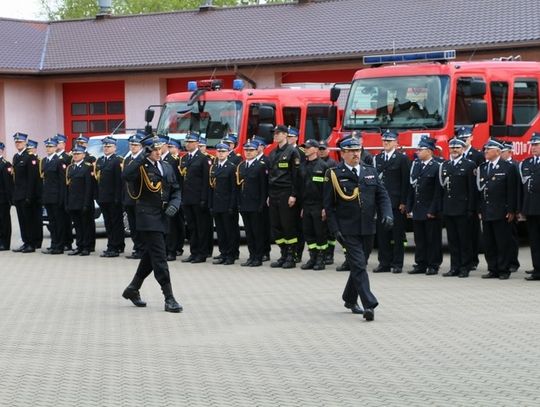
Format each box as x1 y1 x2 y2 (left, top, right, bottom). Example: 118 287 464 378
95 137 125 257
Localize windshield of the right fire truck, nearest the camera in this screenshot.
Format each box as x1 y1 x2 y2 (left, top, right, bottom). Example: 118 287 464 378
343 75 449 130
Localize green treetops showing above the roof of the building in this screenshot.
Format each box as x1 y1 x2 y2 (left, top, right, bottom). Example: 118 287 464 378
40 0 290 20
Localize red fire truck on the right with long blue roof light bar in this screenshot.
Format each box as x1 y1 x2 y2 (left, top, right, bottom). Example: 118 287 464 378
331 51 540 159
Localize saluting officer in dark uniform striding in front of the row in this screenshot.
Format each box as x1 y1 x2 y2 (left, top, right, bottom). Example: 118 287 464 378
122 136 183 313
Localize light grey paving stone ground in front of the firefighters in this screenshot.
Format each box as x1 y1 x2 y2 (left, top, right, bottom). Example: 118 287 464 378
0 230 540 407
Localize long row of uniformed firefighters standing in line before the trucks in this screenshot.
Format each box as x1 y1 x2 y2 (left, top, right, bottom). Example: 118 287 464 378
0 125 540 298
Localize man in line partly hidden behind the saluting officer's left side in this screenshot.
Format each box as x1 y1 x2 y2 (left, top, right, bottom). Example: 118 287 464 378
122 130 146 259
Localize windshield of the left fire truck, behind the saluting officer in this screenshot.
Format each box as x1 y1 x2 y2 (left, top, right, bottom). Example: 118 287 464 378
157 100 242 147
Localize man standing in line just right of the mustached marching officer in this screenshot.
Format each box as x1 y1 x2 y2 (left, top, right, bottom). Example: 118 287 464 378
373 130 410 273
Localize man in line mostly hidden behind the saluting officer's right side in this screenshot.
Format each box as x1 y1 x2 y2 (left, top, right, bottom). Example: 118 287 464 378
161 138 185 261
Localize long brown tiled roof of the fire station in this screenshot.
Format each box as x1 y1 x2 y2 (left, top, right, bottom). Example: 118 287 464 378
0 0 540 74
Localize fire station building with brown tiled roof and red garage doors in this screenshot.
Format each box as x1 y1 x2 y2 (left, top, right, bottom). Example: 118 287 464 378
0 0 540 157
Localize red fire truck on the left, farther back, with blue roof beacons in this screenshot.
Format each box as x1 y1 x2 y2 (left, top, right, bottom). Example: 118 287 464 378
146 79 335 151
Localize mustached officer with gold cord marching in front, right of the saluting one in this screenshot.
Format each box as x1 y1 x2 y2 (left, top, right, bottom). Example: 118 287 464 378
324 138 393 321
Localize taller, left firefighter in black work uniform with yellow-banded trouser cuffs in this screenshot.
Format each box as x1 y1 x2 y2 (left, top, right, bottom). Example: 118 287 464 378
268 125 300 269
